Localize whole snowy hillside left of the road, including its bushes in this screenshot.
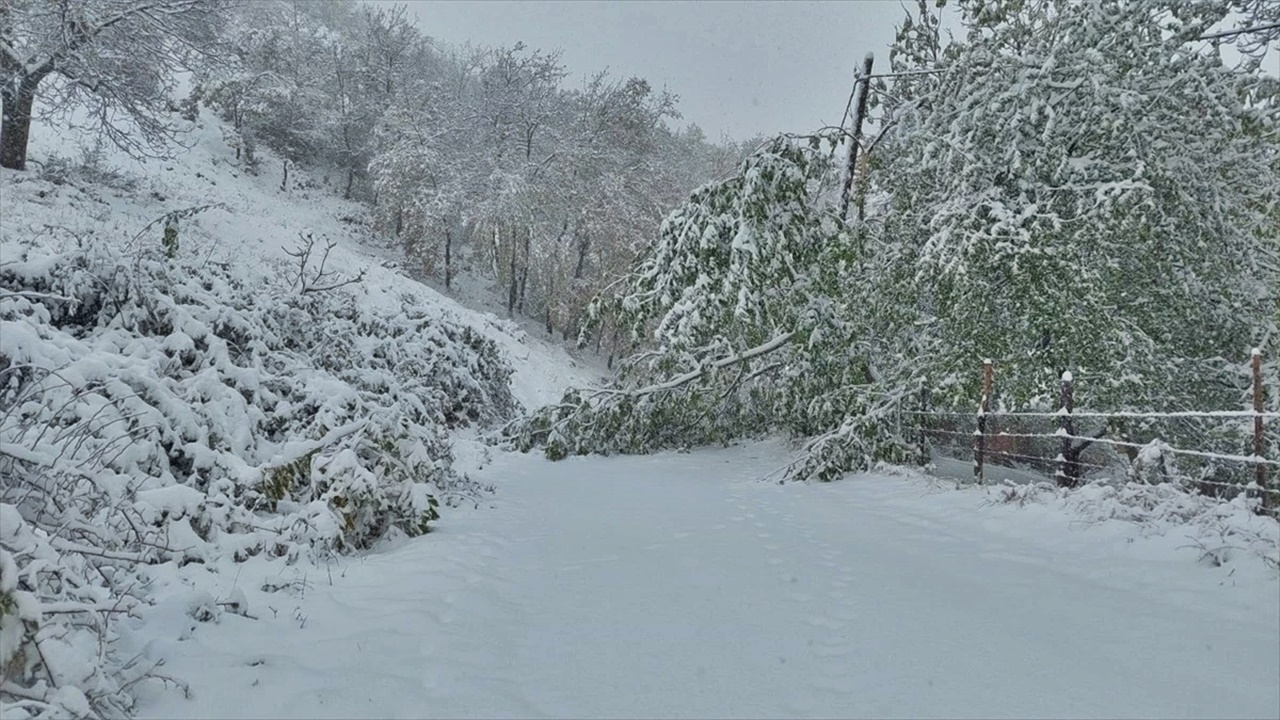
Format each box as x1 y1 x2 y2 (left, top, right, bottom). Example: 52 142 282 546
0 109 595 717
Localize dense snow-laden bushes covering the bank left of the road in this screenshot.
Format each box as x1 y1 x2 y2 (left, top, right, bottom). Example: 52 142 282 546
0 237 515 717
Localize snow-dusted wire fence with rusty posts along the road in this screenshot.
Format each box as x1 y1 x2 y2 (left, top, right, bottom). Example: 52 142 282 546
901 350 1280 515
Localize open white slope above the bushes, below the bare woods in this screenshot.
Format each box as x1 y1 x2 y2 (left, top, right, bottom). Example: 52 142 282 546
0 110 600 407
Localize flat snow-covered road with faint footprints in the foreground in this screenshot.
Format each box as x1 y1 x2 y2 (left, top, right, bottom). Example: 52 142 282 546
141 445 1280 717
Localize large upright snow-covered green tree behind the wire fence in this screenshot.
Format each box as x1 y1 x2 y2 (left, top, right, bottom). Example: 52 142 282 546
867 1 1280 409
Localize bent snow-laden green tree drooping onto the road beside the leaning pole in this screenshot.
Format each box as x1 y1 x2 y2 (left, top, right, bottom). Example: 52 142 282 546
513 136 921 479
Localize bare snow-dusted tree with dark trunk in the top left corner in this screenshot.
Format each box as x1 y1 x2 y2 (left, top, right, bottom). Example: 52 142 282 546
0 0 219 170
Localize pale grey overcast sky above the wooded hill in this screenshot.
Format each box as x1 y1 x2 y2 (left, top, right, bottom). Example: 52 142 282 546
385 0 914 140
